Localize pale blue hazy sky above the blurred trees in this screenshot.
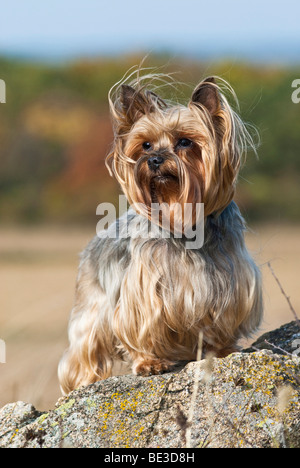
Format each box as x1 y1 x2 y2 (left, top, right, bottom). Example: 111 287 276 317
0 0 300 62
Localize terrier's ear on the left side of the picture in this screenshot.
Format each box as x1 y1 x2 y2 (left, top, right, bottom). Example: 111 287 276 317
120 85 161 124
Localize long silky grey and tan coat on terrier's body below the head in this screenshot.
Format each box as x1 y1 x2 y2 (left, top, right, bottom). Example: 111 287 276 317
59 202 262 392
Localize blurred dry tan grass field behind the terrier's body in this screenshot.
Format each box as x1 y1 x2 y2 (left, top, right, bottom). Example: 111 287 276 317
0 224 300 410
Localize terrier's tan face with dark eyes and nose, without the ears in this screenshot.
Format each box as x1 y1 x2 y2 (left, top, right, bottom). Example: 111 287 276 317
124 108 204 223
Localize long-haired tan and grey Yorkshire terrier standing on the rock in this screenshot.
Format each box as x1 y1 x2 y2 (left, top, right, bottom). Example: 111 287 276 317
59 69 262 393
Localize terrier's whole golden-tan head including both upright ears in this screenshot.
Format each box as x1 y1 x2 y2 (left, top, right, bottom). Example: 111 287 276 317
106 78 247 229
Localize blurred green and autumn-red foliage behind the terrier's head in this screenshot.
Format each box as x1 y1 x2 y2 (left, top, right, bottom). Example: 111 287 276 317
0 56 300 223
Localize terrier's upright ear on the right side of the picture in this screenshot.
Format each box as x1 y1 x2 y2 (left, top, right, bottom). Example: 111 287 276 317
191 77 221 115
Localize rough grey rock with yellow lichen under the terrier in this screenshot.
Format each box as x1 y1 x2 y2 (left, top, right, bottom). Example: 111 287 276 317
0 323 300 448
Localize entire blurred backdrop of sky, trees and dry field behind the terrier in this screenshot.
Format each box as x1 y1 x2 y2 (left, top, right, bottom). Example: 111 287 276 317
0 0 300 409
